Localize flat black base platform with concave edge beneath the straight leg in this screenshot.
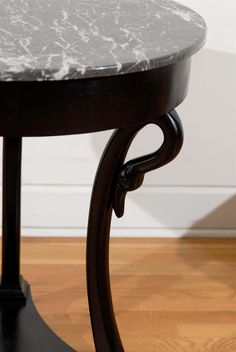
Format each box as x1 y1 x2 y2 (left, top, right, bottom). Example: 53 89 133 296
0 290 75 352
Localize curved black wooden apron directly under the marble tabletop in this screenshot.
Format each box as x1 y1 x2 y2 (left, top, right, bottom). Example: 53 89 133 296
0 59 191 137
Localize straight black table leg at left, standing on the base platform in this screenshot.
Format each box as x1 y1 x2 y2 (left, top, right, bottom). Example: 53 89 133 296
0 137 27 303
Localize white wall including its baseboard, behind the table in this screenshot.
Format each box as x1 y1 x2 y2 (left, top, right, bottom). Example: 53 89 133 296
0 0 236 236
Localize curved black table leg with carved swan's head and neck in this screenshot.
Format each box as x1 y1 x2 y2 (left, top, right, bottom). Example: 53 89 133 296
87 111 183 352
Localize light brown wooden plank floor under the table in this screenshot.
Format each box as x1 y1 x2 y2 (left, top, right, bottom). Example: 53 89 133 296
3 239 236 352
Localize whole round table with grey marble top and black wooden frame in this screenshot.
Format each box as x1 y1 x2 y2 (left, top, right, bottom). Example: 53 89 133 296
0 0 206 352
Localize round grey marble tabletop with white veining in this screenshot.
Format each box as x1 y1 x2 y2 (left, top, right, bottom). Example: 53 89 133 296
0 0 206 81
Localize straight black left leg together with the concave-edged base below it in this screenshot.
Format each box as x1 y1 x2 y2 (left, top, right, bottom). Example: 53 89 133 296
0 137 75 352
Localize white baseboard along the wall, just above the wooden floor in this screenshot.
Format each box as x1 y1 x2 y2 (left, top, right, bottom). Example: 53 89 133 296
0 185 236 237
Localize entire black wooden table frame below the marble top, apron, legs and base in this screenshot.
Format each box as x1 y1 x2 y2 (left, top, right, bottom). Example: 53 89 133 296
0 59 190 352
